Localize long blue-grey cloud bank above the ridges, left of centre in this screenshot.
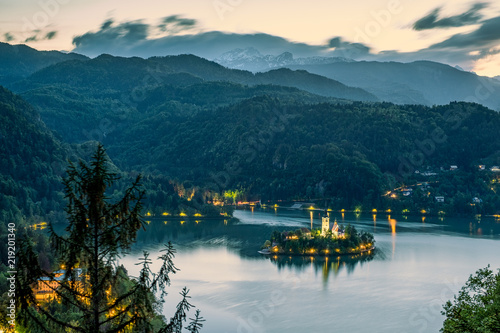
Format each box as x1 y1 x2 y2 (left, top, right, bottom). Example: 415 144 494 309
73 15 340 59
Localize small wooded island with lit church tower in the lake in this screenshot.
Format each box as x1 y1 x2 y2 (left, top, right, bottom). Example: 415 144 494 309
259 217 375 256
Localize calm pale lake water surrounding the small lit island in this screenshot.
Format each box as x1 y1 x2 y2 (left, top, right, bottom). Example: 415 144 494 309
122 208 500 333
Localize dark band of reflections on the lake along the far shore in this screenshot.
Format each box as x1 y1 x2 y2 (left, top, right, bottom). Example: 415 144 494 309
129 207 500 258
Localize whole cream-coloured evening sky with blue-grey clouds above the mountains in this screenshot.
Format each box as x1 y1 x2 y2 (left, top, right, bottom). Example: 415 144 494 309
0 0 500 76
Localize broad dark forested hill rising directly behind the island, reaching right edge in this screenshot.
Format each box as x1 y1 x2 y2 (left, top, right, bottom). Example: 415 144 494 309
110 97 500 214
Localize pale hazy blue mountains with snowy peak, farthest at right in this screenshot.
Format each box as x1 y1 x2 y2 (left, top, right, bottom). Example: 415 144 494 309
214 48 500 111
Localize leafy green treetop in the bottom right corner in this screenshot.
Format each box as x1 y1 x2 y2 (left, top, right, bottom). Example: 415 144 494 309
441 265 500 333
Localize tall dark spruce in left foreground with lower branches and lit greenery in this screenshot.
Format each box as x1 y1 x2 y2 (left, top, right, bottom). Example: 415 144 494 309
18 145 202 333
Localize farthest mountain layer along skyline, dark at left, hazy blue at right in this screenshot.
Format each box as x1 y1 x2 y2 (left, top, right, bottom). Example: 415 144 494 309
0 43 500 111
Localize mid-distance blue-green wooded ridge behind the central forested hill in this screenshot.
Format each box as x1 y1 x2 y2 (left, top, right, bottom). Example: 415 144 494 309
8 55 377 142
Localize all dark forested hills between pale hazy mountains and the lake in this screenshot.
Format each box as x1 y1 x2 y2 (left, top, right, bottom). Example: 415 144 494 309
0 42 500 223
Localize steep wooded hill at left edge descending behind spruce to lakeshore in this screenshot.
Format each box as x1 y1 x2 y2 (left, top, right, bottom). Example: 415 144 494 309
0 86 224 227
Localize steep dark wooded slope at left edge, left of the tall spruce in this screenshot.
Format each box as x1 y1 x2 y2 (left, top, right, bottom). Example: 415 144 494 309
0 87 68 222
